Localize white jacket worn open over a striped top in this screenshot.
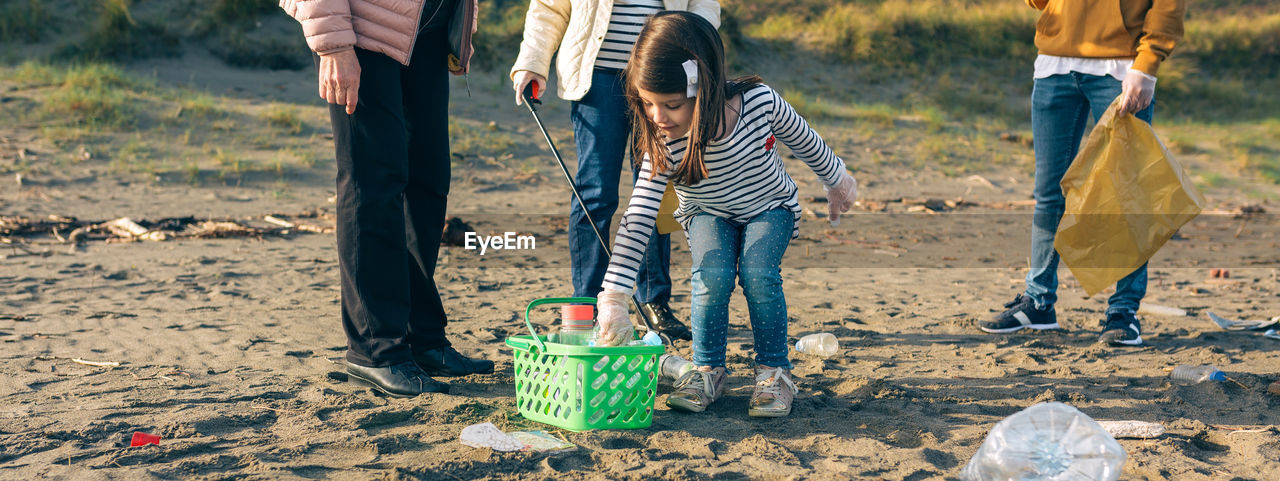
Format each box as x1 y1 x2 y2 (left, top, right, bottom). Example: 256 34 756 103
511 0 719 100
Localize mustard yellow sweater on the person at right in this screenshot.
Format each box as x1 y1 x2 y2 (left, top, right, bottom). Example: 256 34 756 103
1025 0 1187 75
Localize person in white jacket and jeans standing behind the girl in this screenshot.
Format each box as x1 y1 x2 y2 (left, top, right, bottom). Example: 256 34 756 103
511 0 721 340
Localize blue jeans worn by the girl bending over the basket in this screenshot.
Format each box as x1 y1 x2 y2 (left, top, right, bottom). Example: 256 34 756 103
689 207 795 368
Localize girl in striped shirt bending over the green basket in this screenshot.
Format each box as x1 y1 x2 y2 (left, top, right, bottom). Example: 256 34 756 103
596 12 858 417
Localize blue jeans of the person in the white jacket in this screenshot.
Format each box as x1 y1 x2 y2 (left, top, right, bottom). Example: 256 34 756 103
568 70 671 303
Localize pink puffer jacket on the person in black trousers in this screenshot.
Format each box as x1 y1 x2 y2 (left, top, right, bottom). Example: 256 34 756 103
280 0 477 74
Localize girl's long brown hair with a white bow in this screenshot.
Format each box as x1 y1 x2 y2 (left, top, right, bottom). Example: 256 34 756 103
623 12 760 185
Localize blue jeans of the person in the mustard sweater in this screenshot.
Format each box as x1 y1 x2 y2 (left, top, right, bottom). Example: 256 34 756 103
1027 73 1156 315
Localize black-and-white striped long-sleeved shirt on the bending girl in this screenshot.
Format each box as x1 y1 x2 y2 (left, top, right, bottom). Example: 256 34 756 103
604 84 845 292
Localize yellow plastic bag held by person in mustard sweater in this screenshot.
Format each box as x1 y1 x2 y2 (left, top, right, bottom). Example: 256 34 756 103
1053 99 1204 296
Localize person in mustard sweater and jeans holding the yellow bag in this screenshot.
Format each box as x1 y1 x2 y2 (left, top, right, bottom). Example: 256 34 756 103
979 0 1187 345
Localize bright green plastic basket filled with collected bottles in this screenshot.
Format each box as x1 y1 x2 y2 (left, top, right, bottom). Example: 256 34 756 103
507 297 664 431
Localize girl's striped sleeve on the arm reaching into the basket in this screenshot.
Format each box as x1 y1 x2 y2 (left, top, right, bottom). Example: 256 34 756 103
603 155 667 296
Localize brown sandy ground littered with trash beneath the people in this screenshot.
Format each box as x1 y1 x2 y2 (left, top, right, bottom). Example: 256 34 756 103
0 59 1280 481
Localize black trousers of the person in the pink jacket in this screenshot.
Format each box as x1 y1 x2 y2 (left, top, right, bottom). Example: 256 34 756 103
317 24 449 367
